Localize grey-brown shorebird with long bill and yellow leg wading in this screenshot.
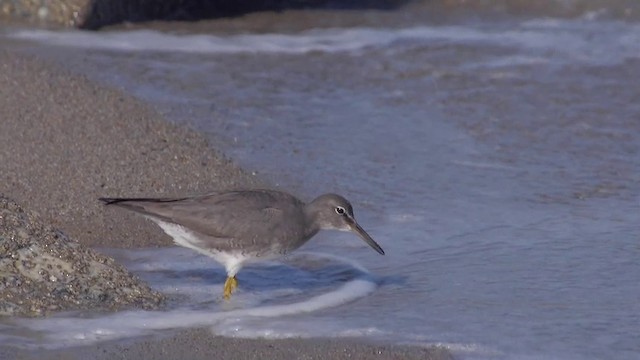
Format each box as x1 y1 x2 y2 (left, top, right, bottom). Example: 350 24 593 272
100 190 384 299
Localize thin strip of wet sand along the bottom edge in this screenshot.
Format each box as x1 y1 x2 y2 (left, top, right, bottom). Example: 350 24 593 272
0 329 453 360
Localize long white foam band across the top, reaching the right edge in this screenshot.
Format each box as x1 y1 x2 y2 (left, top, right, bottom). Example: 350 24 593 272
8 19 640 68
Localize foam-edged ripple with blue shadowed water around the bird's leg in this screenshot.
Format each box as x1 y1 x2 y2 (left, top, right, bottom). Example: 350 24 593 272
5 248 377 348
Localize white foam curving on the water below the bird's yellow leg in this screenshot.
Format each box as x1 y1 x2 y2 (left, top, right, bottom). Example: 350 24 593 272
10 248 377 347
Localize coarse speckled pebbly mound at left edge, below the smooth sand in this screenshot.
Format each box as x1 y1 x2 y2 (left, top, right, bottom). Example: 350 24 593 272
0 194 164 316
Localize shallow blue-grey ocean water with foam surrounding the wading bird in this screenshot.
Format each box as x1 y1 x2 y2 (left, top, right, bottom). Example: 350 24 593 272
5 4 640 359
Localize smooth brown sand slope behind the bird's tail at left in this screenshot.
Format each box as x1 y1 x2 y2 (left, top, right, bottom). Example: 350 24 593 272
0 44 261 248
